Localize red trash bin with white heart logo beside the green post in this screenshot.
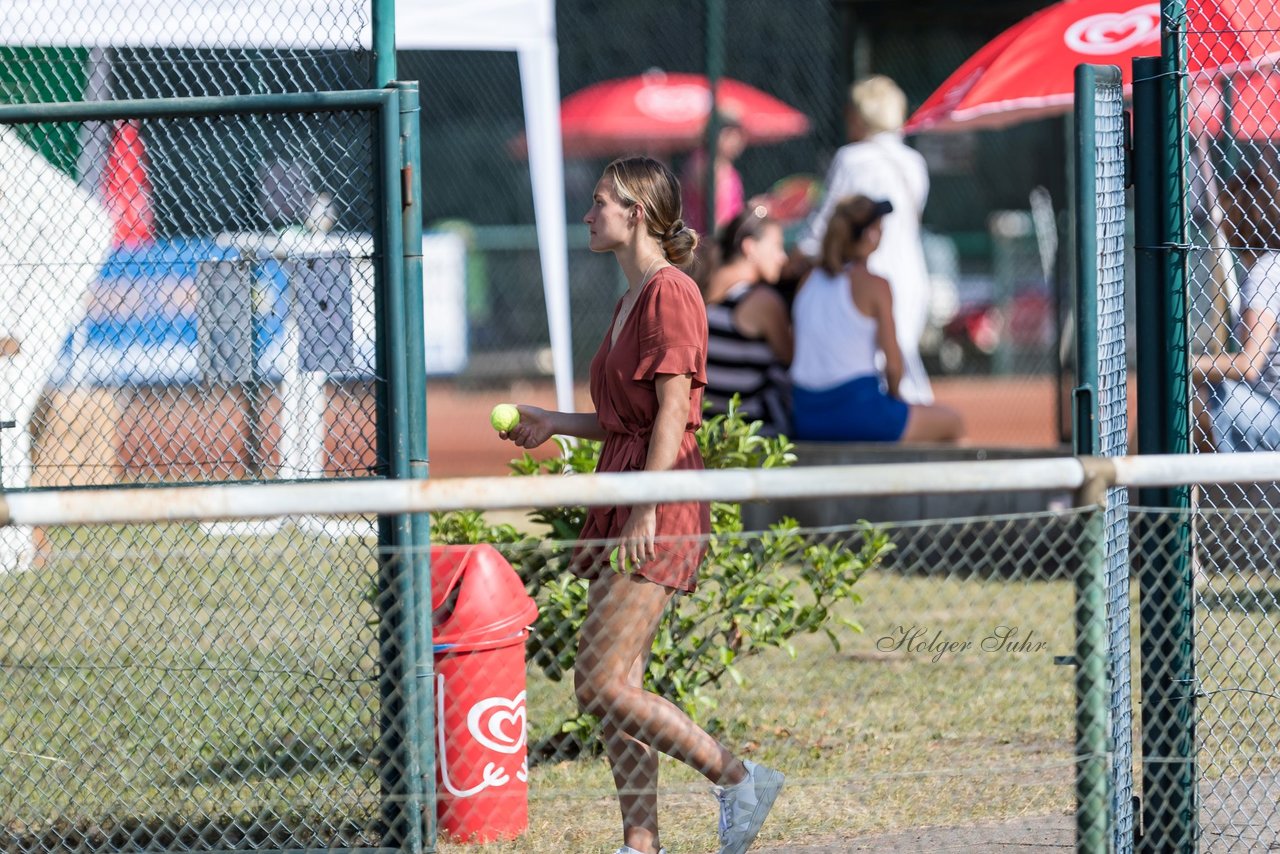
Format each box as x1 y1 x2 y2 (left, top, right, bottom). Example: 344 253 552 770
431 544 538 842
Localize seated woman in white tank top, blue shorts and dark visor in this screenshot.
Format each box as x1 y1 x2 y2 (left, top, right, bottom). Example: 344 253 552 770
791 196 961 442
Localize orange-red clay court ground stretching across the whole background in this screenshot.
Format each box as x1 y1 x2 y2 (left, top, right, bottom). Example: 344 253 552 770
32 376 1090 487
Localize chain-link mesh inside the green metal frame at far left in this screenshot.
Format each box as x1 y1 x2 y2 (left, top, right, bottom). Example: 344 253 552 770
0 92 421 850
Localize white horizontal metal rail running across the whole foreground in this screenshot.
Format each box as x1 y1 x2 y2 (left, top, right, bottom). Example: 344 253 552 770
4 453 1280 525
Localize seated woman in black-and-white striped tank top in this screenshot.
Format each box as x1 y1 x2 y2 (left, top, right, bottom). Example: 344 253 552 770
704 205 794 435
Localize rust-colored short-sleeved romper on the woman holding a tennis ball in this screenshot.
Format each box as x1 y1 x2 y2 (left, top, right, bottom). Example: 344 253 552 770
573 266 710 592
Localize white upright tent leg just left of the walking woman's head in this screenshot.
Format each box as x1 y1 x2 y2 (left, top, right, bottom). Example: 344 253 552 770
520 40 573 412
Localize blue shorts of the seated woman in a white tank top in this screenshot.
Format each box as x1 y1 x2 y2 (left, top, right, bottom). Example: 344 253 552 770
791 376 910 442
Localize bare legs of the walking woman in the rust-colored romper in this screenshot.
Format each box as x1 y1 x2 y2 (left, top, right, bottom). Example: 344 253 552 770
573 572 746 851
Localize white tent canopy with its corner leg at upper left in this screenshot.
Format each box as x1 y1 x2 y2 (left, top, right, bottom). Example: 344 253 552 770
0 0 573 411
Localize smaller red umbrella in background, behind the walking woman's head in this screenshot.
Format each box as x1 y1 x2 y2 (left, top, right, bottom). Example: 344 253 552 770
561 70 809 155
